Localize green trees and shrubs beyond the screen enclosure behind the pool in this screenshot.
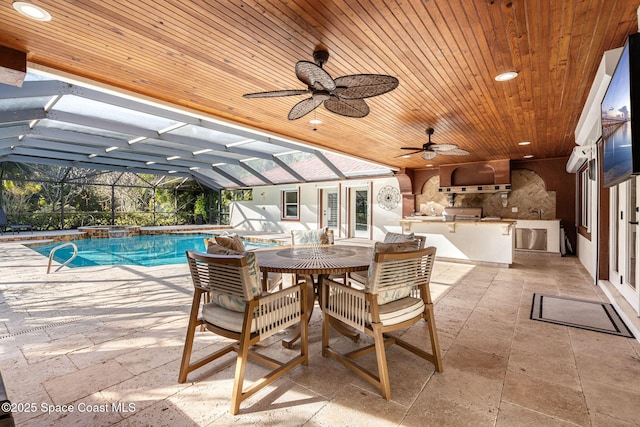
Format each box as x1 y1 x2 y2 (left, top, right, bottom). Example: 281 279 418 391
0 163 219 230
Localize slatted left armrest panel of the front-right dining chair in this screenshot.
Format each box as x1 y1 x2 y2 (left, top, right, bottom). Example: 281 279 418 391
322 278 369 331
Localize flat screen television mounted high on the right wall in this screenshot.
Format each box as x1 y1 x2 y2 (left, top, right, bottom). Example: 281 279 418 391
601 33 640 187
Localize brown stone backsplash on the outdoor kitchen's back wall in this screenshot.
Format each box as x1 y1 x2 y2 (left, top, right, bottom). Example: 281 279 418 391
416 169 556 219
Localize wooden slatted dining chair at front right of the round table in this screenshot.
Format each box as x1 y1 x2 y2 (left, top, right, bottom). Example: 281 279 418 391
321 243 442 400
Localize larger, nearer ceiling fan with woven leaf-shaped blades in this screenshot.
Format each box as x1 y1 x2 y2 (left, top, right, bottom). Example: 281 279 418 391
243 48 399 120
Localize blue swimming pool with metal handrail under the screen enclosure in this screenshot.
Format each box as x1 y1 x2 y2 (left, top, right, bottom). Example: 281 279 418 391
28 234 275 267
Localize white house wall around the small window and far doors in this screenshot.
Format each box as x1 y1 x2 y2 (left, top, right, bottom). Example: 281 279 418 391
230 177 402 240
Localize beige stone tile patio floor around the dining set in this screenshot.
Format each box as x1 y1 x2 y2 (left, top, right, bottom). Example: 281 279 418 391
0 236 640 426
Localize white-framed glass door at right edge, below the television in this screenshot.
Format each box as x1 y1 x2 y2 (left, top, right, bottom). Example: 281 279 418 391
609 178 640 313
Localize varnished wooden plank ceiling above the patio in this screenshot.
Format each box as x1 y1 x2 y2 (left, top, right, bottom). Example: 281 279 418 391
0 0 638 172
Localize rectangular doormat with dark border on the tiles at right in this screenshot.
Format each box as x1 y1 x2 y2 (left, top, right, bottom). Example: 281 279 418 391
529 294 633 338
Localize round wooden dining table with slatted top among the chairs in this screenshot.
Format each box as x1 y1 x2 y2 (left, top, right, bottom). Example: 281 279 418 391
255 245 373 348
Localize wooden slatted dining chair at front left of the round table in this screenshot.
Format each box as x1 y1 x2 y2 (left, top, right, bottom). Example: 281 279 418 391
178 251 308 415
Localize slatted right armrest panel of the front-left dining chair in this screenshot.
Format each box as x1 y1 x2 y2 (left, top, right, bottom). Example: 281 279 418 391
254 285 307 339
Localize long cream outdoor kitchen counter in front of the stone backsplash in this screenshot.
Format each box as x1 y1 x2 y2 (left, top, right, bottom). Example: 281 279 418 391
400 216 516 267
